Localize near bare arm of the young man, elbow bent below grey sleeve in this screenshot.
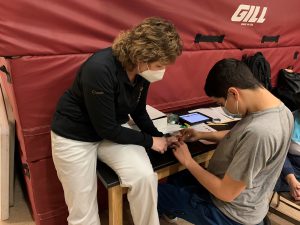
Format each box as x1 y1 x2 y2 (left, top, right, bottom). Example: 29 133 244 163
173 142 246 202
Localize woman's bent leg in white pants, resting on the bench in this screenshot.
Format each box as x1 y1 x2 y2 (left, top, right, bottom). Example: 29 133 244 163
98 140 159 225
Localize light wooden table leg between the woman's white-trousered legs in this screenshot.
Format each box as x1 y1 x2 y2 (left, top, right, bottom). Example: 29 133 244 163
108 185 123 225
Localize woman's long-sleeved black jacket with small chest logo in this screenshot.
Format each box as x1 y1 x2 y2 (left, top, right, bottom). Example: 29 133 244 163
51 48 163 148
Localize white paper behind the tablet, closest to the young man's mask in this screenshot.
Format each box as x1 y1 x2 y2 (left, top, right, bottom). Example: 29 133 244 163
189 107 240 123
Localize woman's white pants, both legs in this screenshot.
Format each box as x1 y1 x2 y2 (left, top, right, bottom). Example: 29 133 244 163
51 132 159 225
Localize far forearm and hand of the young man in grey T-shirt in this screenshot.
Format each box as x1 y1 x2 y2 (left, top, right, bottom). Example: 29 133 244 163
180 128 229 143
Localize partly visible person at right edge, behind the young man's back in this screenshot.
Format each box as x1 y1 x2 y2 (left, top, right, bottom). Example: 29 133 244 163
274 93 300 200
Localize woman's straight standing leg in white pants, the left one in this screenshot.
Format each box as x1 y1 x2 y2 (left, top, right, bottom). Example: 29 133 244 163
51 132 100 225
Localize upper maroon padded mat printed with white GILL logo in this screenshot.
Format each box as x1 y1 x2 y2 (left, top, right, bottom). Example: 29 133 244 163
0 0 300 56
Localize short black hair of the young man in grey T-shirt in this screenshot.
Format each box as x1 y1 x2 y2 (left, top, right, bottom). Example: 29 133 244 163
204 58 262 99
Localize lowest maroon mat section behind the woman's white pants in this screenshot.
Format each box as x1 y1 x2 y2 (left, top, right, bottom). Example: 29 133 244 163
22 158 108 225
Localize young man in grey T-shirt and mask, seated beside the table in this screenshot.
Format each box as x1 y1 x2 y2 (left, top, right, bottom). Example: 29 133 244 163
158 59 293 225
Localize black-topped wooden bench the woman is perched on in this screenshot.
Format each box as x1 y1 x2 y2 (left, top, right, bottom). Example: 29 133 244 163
97 142 216 225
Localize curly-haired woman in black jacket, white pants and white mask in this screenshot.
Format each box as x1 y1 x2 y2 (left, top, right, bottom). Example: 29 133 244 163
51 17 182 225
